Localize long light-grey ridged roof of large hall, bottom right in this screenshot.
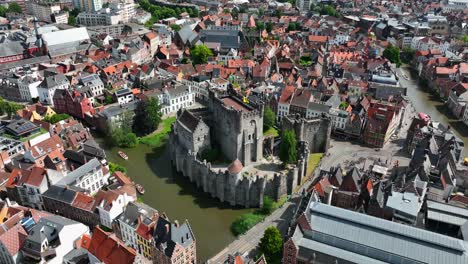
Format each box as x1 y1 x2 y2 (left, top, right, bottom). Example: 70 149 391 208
295 202 468 264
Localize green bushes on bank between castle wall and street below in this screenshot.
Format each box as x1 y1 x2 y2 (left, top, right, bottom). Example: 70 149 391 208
231 195 288 236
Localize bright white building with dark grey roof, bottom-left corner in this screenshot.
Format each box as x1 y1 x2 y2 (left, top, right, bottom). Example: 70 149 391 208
21 215 89 264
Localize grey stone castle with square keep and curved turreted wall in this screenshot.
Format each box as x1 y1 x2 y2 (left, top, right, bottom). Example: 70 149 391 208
167 91 330 207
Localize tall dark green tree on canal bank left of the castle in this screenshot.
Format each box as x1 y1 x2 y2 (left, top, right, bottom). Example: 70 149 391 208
134 97 162 135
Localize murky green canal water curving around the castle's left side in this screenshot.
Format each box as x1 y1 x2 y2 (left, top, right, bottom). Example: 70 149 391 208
96 141 250 263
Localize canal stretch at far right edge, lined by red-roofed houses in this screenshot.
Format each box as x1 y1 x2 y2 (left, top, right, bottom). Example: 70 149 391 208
400 66 468 157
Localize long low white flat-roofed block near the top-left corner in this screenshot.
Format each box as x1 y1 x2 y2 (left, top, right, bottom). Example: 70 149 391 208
76 8 122 26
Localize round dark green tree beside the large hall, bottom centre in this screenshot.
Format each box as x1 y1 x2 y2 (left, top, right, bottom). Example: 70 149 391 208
259 226 283 264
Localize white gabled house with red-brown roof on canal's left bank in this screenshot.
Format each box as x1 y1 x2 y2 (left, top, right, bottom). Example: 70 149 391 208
96 190 135 229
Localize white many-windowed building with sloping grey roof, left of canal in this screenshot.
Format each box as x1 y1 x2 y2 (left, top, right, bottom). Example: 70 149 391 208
57 158 110 195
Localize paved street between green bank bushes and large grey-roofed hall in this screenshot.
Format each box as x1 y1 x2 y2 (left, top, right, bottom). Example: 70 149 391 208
207 202 296 264
